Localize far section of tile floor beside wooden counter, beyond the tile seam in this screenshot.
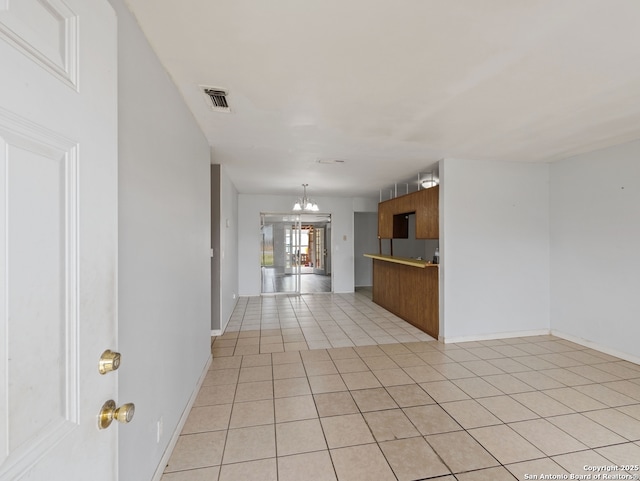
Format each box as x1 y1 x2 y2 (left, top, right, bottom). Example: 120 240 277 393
213 290 433 357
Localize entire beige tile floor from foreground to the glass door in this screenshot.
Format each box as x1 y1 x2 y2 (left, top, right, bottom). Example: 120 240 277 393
162 293 640 481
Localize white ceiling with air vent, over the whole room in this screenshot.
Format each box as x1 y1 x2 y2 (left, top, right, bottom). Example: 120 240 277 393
126 0 640 197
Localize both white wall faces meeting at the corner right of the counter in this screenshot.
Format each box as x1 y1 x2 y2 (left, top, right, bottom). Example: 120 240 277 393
440 148 640 362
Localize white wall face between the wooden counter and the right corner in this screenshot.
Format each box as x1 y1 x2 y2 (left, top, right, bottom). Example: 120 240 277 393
440 159 550 342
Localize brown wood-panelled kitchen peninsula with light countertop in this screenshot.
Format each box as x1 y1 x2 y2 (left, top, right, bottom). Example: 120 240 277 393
364 254 439 339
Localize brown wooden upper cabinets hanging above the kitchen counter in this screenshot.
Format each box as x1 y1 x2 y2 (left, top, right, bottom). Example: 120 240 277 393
378 185 440 239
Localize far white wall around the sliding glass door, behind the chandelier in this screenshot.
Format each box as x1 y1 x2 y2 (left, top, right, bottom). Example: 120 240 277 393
238 194 354 296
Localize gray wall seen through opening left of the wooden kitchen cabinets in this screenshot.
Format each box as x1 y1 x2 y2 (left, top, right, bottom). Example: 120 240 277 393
353 212 379 287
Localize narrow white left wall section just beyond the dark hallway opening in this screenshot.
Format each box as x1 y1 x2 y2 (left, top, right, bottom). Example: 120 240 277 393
220 165 238 331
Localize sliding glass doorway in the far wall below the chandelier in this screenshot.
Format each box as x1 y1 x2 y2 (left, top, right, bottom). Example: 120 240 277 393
260 213 332 294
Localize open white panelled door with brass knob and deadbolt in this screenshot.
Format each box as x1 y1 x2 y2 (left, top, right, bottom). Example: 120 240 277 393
0 0 120 481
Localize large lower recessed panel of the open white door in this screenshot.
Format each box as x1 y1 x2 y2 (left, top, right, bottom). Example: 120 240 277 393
0 118 79 474
